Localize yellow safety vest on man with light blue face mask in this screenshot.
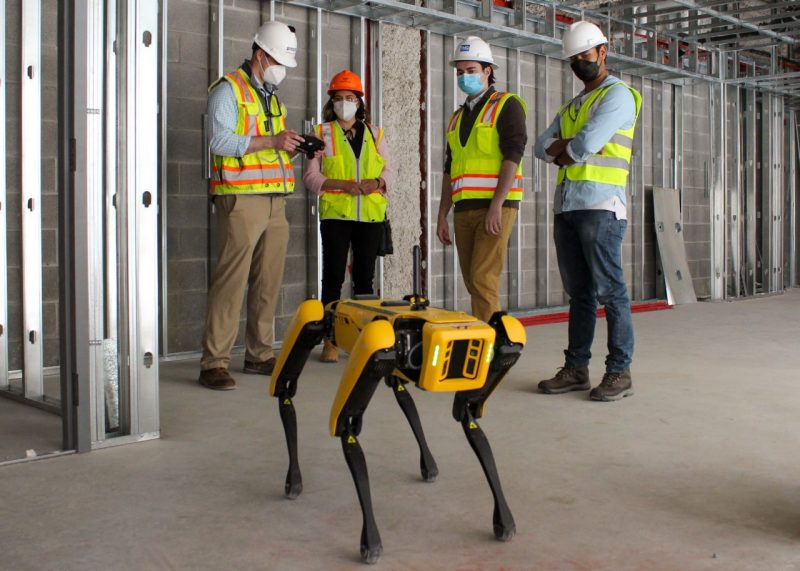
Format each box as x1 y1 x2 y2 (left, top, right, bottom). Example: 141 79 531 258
447 91 528 203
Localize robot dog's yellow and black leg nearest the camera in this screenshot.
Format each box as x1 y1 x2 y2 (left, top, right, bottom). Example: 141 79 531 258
330 320 396 563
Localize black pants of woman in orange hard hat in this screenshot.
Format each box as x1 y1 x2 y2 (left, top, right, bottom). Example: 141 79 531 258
320 220 383 305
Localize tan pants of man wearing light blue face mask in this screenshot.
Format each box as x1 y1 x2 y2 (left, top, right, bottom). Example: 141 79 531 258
453 208 517 321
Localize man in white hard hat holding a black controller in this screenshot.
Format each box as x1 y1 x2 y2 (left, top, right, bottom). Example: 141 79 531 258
199 22 303 390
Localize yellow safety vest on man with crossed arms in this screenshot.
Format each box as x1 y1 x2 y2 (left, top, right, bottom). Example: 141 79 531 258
556 81 642 187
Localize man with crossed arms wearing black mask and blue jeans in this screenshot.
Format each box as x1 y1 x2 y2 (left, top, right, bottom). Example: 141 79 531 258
534 22 642 401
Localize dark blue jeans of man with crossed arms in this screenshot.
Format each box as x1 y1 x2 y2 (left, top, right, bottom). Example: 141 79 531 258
553 210 633 373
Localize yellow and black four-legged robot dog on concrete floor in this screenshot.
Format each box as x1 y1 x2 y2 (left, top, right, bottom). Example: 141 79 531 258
270 246 526 563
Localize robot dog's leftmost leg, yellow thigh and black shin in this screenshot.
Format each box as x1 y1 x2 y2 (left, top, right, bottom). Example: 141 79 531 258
270 299 324 500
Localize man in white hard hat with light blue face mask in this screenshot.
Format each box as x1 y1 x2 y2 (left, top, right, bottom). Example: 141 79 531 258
436 36 528 321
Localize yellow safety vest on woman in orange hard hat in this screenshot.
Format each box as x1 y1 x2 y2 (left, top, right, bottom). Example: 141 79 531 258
314 121 386 222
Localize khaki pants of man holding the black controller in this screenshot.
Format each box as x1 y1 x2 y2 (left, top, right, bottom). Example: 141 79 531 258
200 194 289 370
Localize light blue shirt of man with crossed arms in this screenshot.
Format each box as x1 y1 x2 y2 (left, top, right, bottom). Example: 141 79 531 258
533 75 636 220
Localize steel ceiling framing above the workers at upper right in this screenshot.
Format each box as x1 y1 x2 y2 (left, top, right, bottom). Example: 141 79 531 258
288 0 800 107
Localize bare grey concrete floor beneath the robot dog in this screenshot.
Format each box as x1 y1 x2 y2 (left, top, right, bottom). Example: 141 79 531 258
0 291 800 571
